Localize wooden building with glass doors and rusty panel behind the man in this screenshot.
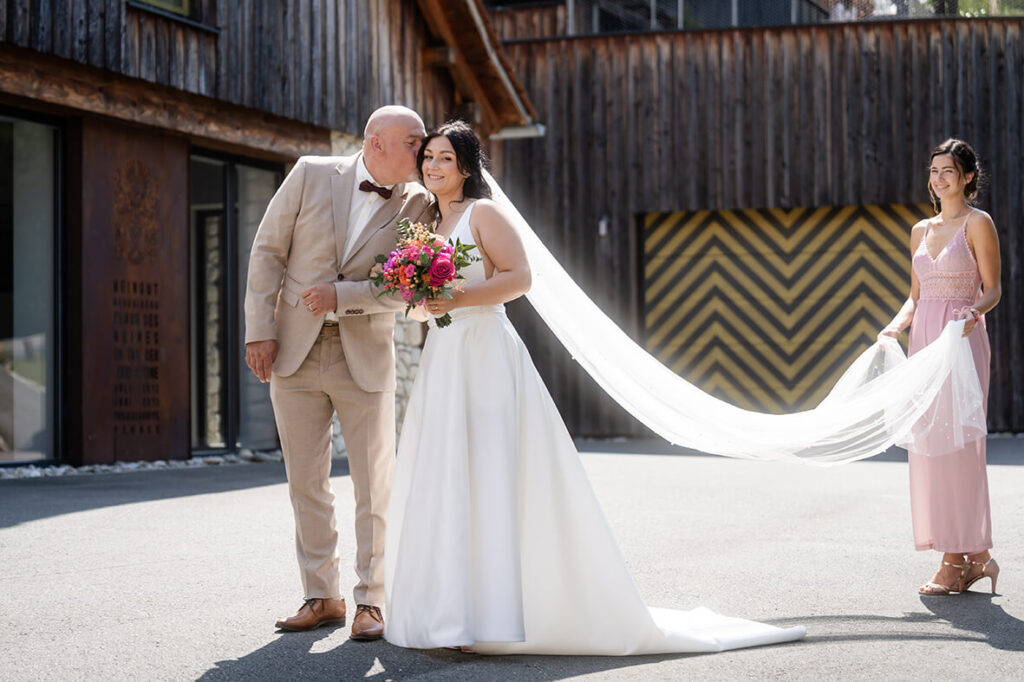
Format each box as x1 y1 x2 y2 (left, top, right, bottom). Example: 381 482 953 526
0 0 534 464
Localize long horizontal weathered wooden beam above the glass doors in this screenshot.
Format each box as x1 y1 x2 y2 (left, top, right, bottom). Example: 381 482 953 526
0 44 331 161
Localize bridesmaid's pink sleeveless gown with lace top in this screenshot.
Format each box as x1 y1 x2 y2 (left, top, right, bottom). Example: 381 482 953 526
909 218 992 554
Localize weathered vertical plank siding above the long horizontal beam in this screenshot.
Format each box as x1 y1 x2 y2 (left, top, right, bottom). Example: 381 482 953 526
0 0 454 135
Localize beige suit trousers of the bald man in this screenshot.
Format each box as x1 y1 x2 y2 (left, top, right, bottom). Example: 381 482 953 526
270 327 395 607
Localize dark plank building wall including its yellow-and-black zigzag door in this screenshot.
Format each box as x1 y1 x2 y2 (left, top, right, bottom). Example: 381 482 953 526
495 17 1024 436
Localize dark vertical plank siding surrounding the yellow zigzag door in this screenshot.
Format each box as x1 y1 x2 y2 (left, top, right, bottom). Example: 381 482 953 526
495 21 1024 436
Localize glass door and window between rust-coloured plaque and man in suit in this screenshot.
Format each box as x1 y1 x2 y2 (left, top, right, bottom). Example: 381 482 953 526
190 155 283 452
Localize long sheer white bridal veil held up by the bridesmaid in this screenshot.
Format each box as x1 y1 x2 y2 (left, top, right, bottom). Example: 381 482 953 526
486 174 986 465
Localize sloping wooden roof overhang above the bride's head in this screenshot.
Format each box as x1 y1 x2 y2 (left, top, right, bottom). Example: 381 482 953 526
417 0 544 139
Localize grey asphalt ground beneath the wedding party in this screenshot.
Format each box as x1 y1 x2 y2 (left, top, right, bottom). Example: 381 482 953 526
0 438 1024 681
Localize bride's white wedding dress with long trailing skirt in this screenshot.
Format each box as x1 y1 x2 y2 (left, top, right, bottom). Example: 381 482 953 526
385 202 806 655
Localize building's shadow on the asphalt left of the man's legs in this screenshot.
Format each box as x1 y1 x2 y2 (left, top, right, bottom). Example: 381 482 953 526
0 459 348 528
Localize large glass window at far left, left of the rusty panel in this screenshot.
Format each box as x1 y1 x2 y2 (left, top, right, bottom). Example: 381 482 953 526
0 116 58 461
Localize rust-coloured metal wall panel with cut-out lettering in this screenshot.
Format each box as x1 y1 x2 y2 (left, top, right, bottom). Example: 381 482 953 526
74 120 189 463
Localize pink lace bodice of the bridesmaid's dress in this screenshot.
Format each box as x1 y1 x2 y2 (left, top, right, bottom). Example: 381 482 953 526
913 214 981 302
